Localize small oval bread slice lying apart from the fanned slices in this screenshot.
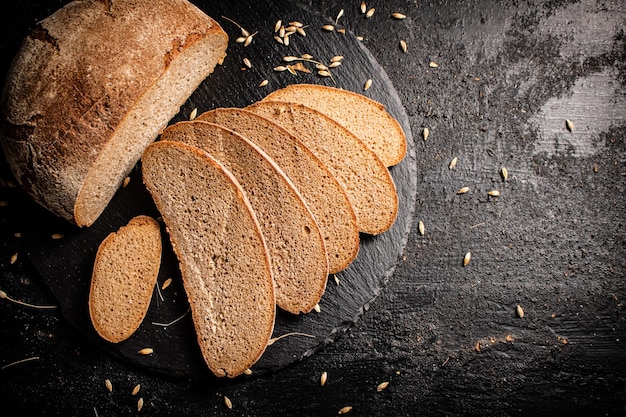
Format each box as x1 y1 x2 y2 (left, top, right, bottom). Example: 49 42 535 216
89 216 161 343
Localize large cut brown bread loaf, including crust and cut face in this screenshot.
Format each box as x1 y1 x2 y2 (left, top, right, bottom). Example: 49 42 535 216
2 0 228 226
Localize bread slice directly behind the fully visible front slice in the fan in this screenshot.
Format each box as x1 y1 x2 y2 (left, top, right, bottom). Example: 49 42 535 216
161 121 328 314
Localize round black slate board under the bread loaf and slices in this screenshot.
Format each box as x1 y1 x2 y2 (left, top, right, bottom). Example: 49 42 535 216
13 0 416 378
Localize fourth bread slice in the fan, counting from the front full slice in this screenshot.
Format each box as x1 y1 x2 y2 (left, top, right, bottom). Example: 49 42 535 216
247 101 398 235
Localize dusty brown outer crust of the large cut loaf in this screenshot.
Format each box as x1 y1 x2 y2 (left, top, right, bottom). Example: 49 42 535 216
2 0 226 221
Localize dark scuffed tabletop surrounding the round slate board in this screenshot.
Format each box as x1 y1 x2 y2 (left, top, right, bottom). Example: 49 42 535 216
0 0 626 416
